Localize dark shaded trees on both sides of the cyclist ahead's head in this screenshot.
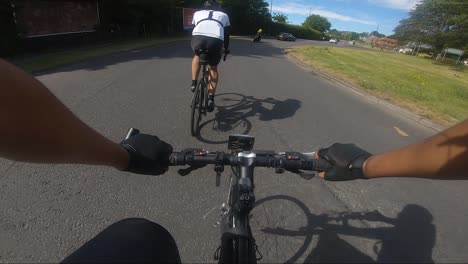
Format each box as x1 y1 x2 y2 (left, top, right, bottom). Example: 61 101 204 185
100 0 328 39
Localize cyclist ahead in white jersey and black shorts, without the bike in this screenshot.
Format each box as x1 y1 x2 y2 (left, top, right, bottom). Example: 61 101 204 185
190 0 231 112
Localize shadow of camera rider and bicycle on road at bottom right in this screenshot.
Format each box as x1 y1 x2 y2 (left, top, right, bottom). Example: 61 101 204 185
254 195 436 263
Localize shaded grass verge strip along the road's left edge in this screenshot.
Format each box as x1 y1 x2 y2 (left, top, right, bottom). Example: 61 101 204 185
12 37 188 72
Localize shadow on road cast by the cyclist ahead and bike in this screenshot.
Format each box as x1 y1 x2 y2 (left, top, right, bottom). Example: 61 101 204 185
197 93 301 144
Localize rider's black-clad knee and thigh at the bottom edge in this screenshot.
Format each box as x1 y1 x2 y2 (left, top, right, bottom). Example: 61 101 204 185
62 218 181 263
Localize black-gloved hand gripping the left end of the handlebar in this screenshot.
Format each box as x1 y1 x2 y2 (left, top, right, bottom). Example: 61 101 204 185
120 134 172 175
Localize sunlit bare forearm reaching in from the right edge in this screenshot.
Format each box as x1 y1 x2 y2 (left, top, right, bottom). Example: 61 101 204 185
364 120 468 179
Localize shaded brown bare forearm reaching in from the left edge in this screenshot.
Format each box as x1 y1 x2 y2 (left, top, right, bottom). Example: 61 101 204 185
0 60 128 169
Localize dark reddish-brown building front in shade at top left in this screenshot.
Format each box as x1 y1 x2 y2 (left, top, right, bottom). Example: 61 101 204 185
9 0 100 52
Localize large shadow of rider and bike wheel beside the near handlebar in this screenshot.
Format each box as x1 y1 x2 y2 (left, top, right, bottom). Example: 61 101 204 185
251 195 436 263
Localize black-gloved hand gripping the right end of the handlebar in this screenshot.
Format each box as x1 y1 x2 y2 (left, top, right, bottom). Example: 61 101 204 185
316 143 371 181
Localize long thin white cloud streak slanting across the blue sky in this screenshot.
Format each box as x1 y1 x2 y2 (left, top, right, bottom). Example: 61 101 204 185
273 3 377 25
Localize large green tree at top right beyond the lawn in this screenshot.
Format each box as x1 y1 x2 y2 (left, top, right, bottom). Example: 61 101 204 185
394 0 468 52
